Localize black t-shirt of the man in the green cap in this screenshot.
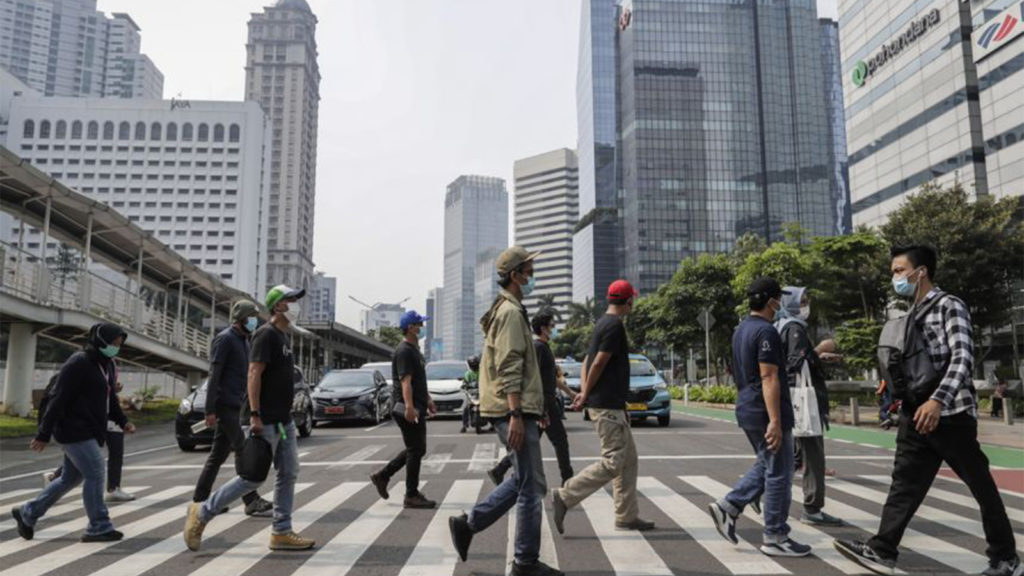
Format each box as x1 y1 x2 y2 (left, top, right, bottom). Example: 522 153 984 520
250 323 295 424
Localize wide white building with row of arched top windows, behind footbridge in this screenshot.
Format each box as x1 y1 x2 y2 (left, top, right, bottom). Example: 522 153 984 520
0 96 270 297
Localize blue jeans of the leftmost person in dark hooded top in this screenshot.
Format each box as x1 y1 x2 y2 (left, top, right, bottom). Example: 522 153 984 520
20 440 114 535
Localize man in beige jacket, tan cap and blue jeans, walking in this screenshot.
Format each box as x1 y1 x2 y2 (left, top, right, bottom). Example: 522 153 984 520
449 246 562 576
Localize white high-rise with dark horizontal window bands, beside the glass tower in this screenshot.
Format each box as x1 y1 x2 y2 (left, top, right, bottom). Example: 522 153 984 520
512 148 580 322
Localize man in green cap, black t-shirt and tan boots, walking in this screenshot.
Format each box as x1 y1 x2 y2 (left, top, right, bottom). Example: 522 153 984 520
184 284 315 550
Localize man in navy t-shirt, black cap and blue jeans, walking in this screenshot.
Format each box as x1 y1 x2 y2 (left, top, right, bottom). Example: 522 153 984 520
709 278 811 557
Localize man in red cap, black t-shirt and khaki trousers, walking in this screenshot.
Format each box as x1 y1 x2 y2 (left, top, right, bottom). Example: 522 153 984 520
552 280 654 534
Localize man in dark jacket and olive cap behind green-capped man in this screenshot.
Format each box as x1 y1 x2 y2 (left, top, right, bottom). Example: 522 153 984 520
193 300 273 516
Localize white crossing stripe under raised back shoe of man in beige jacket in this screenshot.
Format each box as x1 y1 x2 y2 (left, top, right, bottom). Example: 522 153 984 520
399 480 483 576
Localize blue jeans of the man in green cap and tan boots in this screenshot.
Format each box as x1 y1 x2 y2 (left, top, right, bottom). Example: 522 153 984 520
199 422 299 534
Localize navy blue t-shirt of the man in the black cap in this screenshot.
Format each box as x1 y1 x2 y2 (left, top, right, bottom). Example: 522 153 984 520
732 316 793 430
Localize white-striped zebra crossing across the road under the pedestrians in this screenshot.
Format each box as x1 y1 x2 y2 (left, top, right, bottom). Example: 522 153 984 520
0 471 1024 576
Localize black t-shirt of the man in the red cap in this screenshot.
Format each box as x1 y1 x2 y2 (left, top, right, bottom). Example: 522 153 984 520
587 314 630 410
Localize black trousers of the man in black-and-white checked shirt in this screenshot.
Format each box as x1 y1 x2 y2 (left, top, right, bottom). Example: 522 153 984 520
868 413 1017 562
